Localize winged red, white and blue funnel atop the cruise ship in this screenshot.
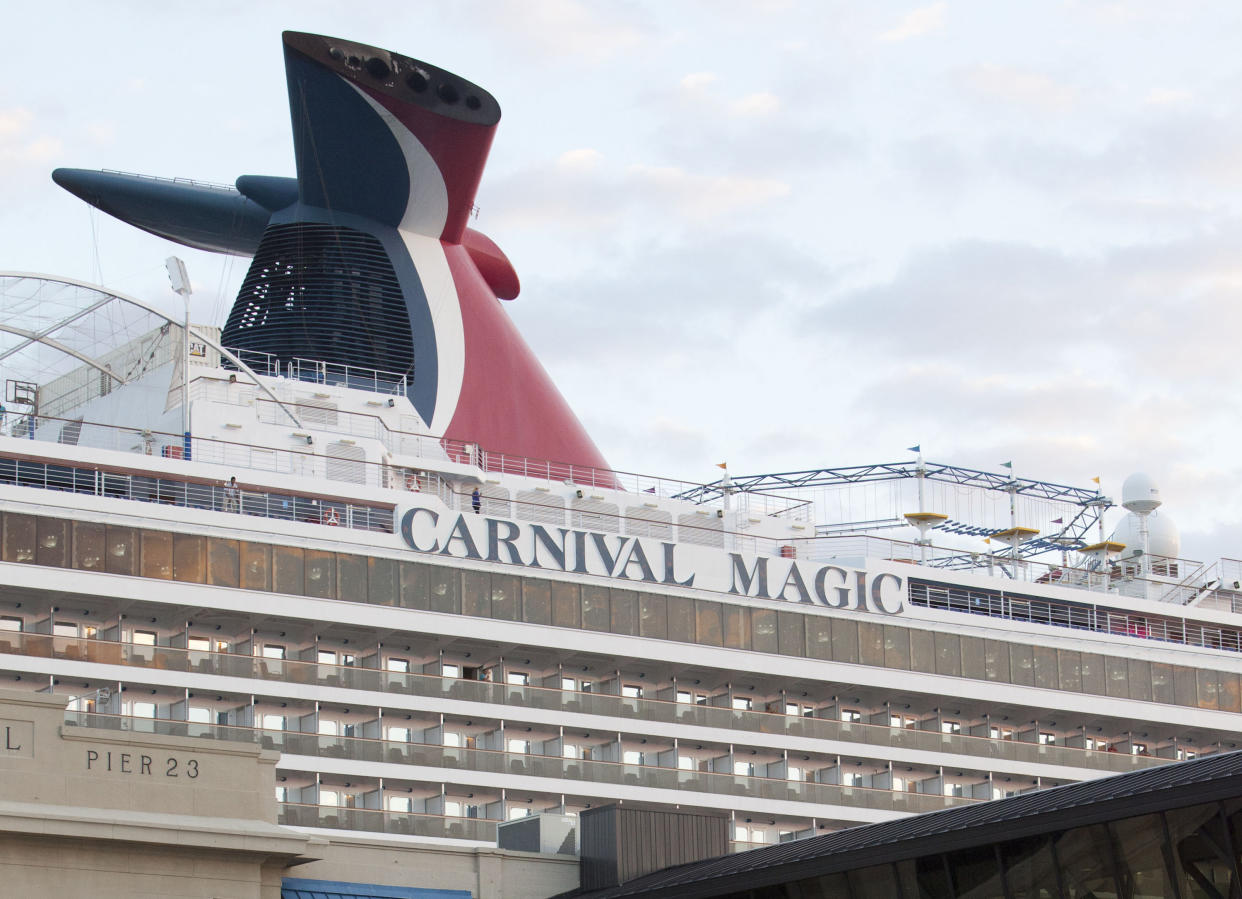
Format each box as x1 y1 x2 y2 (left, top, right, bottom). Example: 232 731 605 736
53 32 607 477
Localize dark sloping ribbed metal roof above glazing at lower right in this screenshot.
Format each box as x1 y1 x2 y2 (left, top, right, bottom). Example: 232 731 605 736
563 751 1242 899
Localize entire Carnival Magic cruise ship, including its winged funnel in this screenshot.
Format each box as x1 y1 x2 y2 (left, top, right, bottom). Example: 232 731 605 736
0 32 1242 849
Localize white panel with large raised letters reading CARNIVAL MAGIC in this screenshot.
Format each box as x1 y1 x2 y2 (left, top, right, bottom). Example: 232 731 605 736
400 507 905 615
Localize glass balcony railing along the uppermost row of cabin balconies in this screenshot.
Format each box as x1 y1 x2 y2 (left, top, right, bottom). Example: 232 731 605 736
12 631 1172 771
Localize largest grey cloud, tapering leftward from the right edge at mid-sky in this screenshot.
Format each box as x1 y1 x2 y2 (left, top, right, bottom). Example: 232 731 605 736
807 228 1242 379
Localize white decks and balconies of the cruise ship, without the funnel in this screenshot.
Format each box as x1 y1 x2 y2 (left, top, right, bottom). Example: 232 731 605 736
0 274 1242 846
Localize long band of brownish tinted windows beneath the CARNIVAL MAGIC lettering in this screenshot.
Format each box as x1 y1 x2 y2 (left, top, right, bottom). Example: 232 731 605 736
9 512 1242 712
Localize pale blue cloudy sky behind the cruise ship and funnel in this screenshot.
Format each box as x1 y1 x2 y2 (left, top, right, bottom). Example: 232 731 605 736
0 0 1242 559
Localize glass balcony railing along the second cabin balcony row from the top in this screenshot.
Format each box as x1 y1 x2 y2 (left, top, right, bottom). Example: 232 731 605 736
65 712 984 813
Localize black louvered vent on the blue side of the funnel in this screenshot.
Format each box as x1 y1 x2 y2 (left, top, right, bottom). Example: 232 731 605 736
221 222 414 376
